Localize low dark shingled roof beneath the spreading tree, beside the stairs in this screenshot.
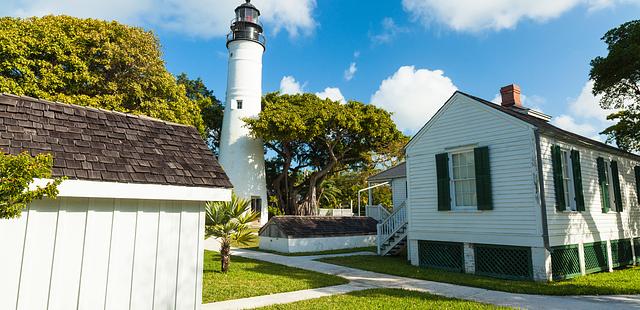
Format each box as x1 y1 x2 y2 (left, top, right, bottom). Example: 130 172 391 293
260 215 378 238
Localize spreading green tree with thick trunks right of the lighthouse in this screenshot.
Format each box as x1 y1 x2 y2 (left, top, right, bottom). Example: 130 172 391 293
246 93 406 215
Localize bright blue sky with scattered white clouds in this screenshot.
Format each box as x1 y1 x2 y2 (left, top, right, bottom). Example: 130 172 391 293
0 0 640 138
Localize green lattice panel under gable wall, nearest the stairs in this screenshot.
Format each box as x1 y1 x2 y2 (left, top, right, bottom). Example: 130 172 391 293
418 240 464 272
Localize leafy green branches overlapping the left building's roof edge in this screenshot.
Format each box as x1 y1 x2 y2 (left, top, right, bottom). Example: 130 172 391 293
0 151 62 219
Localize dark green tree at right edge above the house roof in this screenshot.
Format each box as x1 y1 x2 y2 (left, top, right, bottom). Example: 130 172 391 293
590 20 640 151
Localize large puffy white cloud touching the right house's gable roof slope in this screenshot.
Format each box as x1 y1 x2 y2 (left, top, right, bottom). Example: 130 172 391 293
371 66 457 134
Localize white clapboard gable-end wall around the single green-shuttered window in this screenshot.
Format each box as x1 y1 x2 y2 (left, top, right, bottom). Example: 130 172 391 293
407 94 542 246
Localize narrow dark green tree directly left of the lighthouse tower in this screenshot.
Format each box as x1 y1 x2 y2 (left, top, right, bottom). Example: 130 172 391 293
177 73 224 155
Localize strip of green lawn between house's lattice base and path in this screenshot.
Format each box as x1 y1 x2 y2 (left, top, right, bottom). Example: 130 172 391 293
319 256 640 295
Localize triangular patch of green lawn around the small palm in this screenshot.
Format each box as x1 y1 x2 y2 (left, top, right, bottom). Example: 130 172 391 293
202 251 349 303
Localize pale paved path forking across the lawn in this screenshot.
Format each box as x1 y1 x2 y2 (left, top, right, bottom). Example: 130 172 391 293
202 243 640 310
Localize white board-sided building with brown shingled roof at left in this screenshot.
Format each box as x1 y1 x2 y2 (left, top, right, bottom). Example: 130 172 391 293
0 95 231 310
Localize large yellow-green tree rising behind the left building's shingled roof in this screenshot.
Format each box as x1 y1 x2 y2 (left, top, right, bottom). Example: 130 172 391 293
0 16 205 133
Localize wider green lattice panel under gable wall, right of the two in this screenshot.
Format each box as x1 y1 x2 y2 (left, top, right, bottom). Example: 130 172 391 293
474 244 533 279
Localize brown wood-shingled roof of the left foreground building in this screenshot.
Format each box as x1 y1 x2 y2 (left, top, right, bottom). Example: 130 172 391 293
0 94 232 188
